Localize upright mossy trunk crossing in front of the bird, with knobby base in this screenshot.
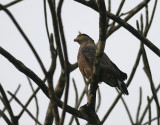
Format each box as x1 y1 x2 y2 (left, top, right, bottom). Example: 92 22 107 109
80 0 106 125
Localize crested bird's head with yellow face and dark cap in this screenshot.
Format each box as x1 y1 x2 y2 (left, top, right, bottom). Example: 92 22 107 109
74 34 94 45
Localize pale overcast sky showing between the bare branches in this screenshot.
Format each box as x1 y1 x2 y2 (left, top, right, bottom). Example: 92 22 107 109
0 0 160 125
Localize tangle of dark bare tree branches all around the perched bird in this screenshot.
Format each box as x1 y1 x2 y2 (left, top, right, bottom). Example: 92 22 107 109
0 0 160 125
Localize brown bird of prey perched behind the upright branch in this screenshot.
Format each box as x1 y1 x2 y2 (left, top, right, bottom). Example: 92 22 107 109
74 34 128 95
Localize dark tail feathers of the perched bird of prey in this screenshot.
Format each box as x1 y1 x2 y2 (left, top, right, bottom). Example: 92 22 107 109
117 80 129 95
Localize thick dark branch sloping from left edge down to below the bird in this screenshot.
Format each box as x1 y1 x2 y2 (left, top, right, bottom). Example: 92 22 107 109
0 46 89 120
